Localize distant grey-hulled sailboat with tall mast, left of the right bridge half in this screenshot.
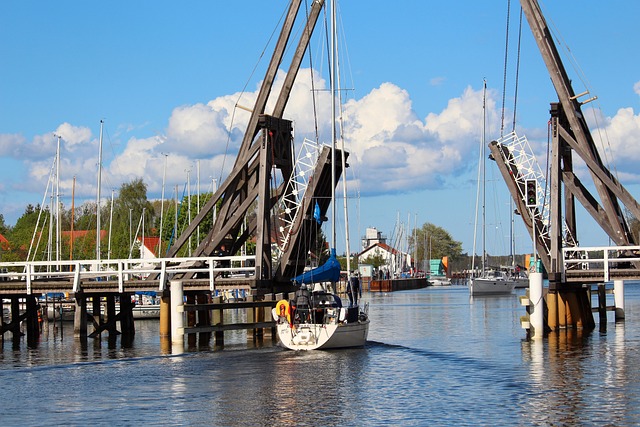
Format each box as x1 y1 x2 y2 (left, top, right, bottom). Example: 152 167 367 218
469 81 516 296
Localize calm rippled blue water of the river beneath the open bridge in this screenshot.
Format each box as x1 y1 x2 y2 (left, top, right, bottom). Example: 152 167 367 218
0 284 640 426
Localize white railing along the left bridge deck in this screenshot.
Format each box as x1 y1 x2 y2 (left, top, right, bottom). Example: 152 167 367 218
0 255 255 295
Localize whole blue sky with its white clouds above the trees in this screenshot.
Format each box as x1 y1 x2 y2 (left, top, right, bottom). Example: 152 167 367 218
0 0 640 254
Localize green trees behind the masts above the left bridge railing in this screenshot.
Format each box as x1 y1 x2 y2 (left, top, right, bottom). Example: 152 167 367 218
0 178 218 262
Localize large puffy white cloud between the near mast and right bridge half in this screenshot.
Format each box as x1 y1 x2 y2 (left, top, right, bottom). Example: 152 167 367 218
345 83 496 194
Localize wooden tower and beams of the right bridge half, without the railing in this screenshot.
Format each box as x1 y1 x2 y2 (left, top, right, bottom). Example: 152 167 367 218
490 0 640 330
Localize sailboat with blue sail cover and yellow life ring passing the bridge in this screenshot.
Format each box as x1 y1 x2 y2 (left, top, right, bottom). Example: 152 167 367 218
272 1 370 350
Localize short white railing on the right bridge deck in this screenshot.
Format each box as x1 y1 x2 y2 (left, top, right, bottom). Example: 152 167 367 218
562 246 640 282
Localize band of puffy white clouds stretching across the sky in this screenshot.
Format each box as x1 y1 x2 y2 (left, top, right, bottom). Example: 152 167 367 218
6 69 640 217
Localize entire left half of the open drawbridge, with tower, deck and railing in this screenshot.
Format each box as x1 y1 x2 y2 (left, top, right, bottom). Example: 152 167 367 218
0 0 348 344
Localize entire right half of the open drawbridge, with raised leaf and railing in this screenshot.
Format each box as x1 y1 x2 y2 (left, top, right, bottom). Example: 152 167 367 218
489 0 640 330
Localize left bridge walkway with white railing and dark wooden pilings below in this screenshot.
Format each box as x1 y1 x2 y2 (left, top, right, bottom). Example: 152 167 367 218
0 256 276 345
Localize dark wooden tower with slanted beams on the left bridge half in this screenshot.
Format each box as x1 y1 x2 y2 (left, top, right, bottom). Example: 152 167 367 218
162 0 342 292
